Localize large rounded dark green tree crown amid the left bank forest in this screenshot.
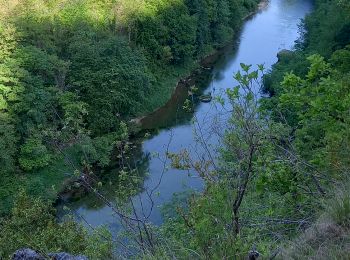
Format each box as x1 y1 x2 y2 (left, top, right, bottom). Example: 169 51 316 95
69 32 151 135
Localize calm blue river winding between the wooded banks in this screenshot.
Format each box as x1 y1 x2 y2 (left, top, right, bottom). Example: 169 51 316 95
58 0 313 240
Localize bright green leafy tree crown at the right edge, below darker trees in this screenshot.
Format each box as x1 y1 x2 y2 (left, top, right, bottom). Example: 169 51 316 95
278 56 350 164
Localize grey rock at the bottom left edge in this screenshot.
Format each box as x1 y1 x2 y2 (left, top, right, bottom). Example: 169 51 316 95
12 248 88 260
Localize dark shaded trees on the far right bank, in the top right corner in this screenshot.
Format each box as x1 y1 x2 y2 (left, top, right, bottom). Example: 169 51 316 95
265 0 350 99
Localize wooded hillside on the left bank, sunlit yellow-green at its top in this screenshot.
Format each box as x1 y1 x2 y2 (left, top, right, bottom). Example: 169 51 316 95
0 0 258 214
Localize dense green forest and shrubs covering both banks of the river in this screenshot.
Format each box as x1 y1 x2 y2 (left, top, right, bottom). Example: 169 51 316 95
0 0 350 259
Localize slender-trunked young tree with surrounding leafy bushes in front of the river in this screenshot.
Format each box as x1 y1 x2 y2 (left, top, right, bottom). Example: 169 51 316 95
164 64 304 259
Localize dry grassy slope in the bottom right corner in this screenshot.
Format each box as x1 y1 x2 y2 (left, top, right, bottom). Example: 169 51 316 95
278 184 350 260
